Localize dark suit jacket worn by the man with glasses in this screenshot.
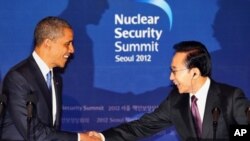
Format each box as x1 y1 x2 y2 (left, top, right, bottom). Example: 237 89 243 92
102 80 247 141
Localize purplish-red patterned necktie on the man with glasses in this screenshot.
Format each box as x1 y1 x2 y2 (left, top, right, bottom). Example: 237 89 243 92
191 95 202 137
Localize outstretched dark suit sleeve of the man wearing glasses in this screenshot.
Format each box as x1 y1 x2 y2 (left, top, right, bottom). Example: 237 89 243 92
102 93 172 141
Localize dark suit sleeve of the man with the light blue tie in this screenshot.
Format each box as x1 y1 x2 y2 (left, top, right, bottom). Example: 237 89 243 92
3 71 77 141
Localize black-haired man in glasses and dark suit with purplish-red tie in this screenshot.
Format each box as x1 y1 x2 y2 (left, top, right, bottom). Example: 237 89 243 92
92 41 250 141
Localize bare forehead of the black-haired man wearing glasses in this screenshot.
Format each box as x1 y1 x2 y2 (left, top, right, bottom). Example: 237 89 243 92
171 52 186 68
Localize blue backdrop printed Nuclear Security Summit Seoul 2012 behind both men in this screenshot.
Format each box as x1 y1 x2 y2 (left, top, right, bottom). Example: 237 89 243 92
0 0 250 141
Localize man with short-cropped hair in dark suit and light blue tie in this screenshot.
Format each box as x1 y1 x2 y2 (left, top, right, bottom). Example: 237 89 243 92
1 17 100 141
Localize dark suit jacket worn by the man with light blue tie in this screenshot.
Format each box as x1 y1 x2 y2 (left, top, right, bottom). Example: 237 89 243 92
1 56 77 141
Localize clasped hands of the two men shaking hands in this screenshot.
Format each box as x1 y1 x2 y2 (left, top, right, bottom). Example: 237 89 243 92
79 131 105 141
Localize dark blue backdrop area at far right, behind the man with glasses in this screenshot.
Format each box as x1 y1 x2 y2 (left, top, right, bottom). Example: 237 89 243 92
212 0 250 97
